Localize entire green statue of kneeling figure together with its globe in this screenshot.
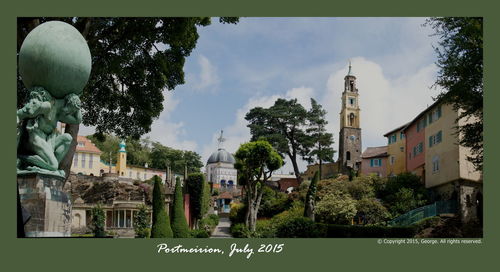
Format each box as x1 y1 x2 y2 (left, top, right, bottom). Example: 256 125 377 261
17 21 91 178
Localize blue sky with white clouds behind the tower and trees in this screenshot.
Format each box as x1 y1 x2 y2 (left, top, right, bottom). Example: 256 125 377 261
80 18 440 173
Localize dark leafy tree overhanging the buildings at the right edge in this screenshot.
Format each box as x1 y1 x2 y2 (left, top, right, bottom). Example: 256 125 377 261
426 17 483 170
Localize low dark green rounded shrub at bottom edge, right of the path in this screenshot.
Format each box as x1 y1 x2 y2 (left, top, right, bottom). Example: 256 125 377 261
276 217 317 238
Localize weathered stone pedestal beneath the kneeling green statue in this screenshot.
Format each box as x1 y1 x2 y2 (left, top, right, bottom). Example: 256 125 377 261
17 173 71 237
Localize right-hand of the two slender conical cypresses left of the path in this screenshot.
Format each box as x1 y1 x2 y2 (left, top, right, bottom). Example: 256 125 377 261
171 177 189 238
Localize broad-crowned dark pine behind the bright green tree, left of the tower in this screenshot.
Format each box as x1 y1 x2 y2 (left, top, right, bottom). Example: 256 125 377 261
245 98 311 183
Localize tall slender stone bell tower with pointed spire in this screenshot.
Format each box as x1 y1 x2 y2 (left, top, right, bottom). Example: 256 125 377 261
338 62 361 174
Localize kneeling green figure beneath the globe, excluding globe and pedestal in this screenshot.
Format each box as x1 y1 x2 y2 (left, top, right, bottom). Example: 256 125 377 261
17 87 82 177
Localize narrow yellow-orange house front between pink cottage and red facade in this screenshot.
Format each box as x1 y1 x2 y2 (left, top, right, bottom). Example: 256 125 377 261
384 124 407 177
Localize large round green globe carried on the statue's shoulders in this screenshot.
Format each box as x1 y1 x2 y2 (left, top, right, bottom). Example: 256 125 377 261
19 21 92 98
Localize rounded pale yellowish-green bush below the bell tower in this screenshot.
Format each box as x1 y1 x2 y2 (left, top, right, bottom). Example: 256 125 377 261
314 192 357 224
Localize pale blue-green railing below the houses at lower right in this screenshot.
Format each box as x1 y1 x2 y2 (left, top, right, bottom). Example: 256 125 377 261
389 200 457 226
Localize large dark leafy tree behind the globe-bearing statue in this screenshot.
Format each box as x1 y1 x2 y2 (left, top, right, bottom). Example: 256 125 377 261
17 17 238 178
